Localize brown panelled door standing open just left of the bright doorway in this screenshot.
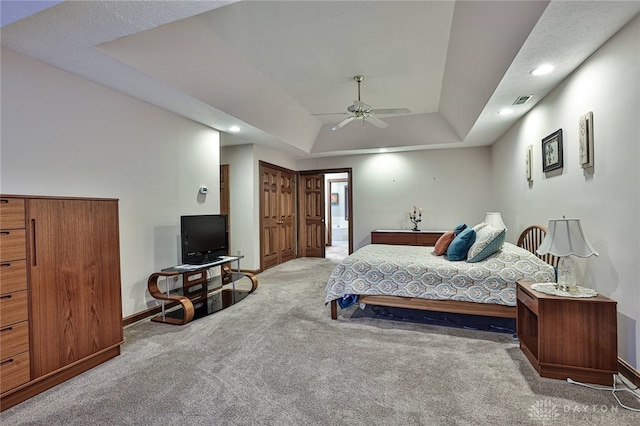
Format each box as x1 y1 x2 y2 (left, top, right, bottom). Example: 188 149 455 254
298 174 325 257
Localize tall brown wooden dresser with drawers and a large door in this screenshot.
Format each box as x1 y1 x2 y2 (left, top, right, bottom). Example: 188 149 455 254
0 195 123 410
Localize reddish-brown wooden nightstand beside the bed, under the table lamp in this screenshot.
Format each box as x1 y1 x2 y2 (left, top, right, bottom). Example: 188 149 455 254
517 281 618 386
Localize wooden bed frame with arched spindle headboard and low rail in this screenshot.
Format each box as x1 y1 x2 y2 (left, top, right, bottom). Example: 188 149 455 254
330 225 558 320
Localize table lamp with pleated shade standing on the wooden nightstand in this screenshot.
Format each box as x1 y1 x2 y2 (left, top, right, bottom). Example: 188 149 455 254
536 217 598 293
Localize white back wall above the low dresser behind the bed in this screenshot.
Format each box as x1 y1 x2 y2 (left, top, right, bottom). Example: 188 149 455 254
298 147 492 250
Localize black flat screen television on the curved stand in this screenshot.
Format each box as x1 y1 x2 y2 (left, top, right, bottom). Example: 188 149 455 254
180 214 229 265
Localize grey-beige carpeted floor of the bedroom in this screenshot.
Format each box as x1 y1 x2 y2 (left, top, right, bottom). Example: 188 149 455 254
0 258 640 426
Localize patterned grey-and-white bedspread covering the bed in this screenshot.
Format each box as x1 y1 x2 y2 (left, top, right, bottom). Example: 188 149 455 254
325 243 555 306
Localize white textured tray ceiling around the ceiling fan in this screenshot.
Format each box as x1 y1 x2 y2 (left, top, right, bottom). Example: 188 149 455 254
1 1 640 157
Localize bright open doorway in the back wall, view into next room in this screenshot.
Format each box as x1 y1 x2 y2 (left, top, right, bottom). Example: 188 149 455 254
324 172 350 260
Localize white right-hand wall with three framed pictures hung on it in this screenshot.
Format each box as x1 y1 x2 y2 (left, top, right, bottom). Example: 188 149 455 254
492 17 640 368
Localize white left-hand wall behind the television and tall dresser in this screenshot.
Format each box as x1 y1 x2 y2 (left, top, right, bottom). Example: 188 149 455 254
0 48 220 316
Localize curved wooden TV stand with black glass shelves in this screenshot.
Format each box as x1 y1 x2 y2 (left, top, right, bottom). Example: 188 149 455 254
147 256 258 325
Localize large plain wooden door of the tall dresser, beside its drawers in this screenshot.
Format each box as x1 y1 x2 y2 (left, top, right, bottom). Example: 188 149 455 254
28 199 123 378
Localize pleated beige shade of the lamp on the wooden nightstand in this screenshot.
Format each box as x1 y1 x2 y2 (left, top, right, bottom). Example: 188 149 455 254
537 218 598 257
